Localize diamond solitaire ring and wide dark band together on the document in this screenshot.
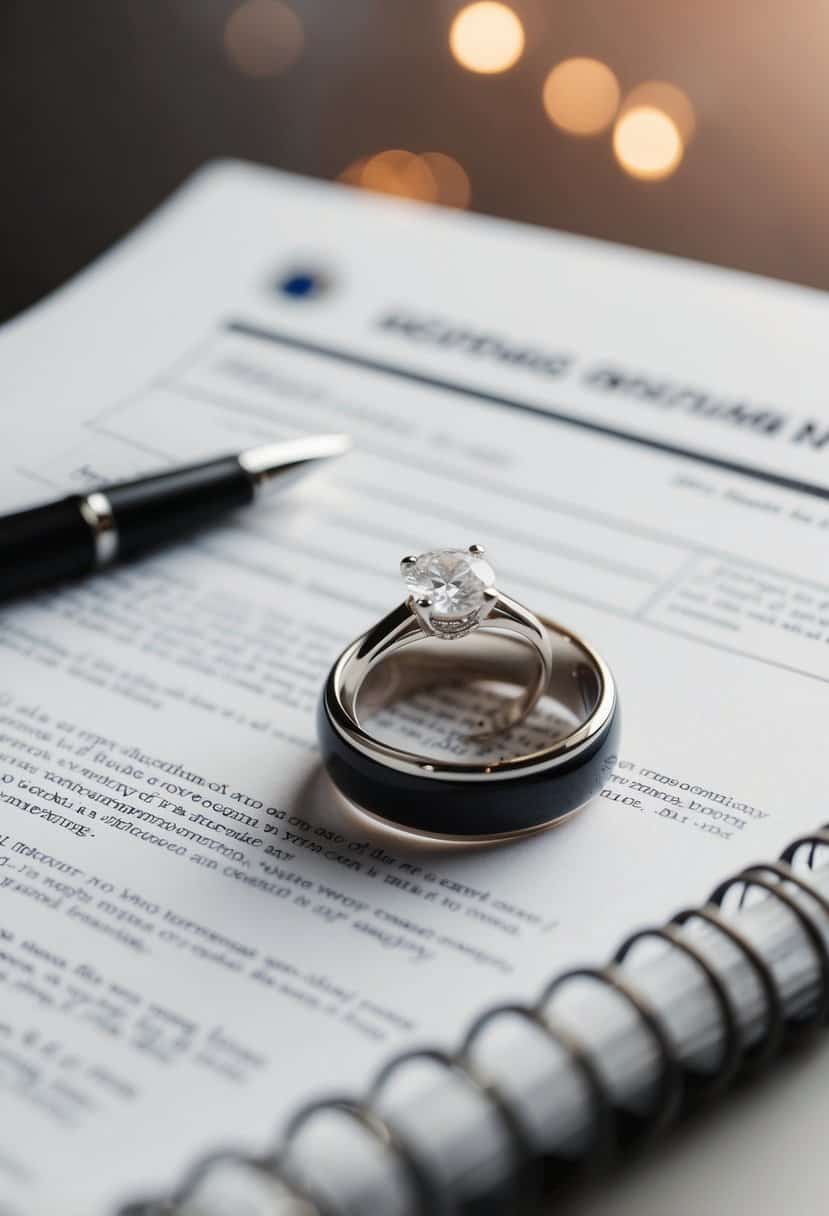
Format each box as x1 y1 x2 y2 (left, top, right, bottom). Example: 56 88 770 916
317 545 619 840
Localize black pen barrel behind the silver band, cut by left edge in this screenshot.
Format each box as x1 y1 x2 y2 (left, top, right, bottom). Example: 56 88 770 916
0 496 95 599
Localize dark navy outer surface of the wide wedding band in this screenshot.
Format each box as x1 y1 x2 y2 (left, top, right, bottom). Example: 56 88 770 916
317 680 620 838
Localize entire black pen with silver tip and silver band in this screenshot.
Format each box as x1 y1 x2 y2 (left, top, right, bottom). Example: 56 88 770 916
0 435 350 599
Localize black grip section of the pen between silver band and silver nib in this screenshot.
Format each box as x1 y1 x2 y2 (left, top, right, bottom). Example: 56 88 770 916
103 456 254 558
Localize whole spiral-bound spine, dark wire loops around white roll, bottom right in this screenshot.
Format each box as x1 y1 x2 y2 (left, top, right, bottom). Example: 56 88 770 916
130 824 829 1216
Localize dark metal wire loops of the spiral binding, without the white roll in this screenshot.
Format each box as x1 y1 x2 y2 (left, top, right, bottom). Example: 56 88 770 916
127 824 829 1216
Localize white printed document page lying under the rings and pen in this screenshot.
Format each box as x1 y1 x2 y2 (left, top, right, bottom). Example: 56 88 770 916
0 164 829 1216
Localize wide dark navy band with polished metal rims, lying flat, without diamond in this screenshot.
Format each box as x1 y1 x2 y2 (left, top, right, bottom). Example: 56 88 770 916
317 618 612 840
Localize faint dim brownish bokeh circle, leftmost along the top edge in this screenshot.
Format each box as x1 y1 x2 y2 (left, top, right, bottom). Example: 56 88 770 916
225 0 305 79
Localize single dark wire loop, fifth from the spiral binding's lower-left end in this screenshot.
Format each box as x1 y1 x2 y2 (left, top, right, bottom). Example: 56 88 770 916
538 963 684 1143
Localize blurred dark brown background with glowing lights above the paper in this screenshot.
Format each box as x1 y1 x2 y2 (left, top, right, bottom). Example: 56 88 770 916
0 0 829 317
